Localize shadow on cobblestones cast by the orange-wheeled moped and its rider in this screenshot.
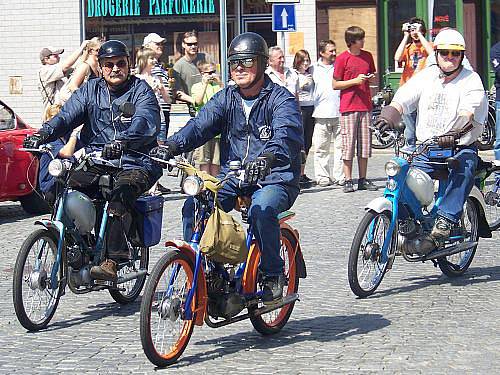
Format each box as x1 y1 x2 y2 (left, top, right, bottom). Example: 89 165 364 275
164 314 391 369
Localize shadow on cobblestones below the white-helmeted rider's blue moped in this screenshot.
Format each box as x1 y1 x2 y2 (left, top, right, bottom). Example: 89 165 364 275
368 266 500 299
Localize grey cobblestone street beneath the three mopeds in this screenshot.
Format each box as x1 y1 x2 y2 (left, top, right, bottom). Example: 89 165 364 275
0 153 500 374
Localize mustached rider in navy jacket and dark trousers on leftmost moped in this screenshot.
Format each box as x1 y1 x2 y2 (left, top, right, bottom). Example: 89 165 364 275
24 40 162 281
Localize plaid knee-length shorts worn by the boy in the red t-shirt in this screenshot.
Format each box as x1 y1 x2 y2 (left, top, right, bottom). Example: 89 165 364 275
340 112 372 160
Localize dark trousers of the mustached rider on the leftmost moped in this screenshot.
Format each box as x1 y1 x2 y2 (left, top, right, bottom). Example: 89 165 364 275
69 169 153 260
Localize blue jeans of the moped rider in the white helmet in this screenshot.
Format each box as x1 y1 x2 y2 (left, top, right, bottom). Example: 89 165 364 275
413 146 478 223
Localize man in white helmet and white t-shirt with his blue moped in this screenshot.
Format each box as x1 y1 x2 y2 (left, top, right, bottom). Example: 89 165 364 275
349 29 491 297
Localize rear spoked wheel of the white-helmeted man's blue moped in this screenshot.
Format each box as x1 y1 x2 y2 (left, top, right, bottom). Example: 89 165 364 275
437 198 479 277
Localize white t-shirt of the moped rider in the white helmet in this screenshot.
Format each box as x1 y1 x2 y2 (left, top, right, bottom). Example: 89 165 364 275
393 66 488 145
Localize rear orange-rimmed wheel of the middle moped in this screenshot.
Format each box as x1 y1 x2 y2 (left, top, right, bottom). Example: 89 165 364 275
252 230 299 335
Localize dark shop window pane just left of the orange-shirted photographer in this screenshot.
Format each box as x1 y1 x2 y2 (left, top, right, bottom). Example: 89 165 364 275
388 0 416 71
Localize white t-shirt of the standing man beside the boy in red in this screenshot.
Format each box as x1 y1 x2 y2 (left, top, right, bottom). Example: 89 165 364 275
313 61 340 118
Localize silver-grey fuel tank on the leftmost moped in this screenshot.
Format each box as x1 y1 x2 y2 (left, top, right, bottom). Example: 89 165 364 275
64 190 96 234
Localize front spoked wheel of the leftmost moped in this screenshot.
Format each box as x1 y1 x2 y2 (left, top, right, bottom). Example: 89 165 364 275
13 229 61 331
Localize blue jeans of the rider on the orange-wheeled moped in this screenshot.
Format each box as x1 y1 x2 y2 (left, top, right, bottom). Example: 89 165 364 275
182 178 298 276
